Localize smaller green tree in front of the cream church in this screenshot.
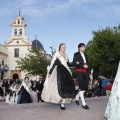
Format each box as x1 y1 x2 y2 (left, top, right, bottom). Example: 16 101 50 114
16 48 50 76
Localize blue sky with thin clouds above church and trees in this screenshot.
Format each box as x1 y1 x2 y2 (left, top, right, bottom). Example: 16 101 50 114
0 0 120 61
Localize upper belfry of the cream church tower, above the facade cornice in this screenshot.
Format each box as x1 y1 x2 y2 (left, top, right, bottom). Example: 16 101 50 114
5 11 30 46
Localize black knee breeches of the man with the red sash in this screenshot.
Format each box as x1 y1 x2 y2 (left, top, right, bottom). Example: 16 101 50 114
76 72 88 90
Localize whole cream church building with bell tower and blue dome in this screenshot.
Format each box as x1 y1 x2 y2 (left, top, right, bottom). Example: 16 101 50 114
0 15 51 79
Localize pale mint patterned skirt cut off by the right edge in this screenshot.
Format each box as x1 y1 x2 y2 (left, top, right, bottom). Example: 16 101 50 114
104 63 120 120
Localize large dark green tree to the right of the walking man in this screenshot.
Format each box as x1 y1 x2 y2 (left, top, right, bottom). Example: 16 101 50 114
86 25 120 78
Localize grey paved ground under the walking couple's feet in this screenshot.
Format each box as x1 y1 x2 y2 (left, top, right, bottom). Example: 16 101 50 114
0 97 108 120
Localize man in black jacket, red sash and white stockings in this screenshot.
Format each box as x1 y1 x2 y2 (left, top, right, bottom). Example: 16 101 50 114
73 43 92 109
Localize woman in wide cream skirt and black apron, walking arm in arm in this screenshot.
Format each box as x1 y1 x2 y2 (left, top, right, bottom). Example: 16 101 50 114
42 43 76 110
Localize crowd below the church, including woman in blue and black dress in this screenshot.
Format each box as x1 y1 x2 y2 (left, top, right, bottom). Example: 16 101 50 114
0 75 44 105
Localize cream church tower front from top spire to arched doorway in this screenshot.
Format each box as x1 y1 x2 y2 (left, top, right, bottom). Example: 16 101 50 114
4 11 32 79
